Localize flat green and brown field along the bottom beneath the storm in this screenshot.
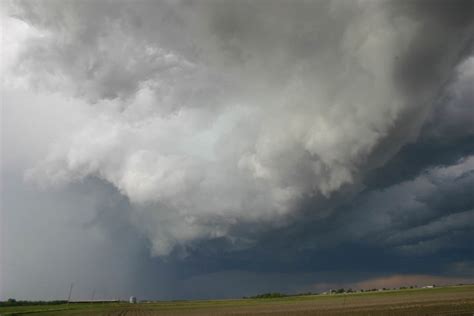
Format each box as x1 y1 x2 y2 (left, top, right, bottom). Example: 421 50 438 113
0 285 474 316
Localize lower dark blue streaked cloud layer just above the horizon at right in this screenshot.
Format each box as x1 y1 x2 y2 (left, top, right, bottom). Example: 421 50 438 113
168 158 474 287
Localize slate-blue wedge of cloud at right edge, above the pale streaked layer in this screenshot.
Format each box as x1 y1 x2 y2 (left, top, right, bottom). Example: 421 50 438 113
365 57 474 188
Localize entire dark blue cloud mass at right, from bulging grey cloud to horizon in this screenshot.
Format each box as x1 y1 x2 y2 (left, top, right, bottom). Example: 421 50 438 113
165 53 474 284
